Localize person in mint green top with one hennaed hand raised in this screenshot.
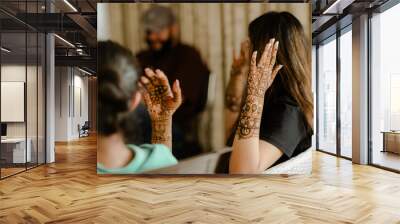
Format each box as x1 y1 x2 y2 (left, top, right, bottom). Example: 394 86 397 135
97 41 182 174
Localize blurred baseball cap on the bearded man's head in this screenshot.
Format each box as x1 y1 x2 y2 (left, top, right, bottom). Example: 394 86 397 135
142 6 176 32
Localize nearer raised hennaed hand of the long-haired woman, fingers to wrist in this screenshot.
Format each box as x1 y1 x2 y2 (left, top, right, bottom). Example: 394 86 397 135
247 39 282 97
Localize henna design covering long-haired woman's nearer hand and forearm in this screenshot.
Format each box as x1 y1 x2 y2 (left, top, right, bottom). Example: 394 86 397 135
236 39 282 139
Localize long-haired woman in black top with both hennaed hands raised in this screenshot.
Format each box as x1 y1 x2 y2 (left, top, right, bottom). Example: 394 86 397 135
226 12 313 174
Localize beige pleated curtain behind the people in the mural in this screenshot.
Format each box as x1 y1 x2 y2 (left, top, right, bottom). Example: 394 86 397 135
97 3 311 150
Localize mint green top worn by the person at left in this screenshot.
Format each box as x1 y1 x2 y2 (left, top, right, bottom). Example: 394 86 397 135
97 144 178 174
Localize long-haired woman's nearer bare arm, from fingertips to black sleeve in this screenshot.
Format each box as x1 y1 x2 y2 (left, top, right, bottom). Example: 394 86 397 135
229 39 282 174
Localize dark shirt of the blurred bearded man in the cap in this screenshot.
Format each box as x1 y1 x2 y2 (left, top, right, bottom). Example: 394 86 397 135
137 43 210 159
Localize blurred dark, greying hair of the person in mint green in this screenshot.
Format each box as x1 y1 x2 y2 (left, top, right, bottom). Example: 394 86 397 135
97 41 140 135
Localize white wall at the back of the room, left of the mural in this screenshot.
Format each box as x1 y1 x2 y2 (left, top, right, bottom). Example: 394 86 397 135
55 67 88 141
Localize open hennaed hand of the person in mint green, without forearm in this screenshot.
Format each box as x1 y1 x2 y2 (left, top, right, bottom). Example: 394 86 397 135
140 68 182 120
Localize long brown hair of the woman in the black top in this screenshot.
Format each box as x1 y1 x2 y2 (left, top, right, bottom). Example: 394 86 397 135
249 12 313 128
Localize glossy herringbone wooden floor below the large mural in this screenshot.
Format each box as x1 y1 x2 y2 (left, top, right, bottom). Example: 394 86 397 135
0 134 400 224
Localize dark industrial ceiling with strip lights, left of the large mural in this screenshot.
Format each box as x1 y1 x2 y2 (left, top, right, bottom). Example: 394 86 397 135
0 0 99 72
